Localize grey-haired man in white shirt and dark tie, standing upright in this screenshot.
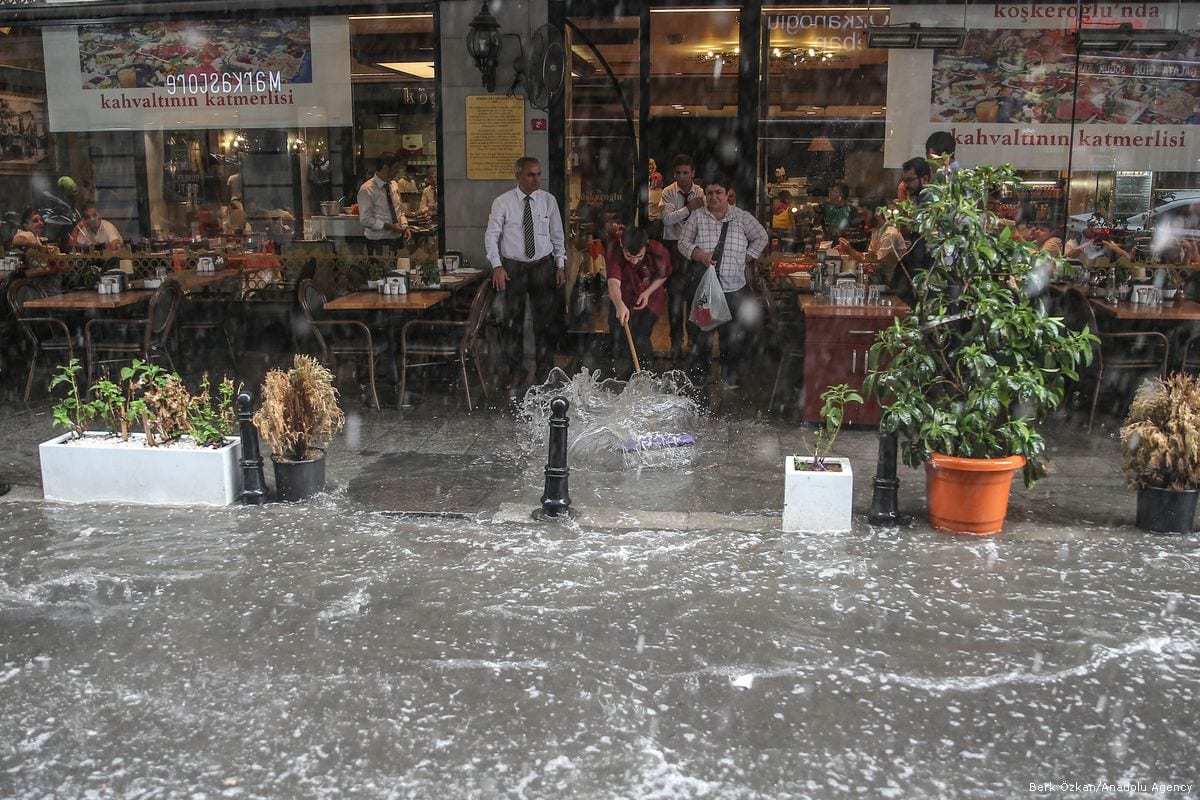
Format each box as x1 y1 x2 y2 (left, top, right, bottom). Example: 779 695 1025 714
484 156 566 391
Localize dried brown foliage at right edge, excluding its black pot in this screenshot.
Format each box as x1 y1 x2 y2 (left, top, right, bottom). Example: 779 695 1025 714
1121 373 1200 489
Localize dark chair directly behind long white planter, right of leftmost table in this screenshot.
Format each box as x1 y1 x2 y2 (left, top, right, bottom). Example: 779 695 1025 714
83 278 184 383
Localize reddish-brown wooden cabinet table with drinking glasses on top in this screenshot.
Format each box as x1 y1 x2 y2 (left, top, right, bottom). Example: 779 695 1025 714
797 294 908 425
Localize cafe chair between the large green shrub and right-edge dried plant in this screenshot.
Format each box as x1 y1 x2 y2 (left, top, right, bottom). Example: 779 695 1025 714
1062 287 1171 431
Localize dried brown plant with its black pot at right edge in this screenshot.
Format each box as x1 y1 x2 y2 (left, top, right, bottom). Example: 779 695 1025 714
1121 373 1200 534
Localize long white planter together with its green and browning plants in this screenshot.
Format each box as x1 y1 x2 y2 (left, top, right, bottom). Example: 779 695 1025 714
38 359 241 505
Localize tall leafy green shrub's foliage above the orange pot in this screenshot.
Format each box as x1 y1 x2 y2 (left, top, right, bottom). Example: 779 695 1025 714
864 164 1097 485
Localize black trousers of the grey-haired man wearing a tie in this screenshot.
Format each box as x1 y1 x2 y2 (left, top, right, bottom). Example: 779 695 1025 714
496 257 563 380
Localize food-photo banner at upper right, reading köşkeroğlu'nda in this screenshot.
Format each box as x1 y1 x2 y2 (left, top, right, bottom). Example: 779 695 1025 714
884 2 1200 172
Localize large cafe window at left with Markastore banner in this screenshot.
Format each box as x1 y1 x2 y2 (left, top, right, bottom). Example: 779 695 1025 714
0 12 438 252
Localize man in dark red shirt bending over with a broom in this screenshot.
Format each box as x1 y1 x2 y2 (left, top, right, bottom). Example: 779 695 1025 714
605 227 671 379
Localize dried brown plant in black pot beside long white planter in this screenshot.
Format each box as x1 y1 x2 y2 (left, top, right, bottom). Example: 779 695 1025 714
253 355 346 501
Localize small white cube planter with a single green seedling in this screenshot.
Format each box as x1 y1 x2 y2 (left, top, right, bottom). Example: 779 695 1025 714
784 384 863 533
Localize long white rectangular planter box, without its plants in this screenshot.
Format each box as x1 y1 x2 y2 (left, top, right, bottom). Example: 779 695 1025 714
37 433 241 506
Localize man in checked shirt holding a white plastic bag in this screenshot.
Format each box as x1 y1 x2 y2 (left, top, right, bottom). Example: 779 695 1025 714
678 178 767 390
